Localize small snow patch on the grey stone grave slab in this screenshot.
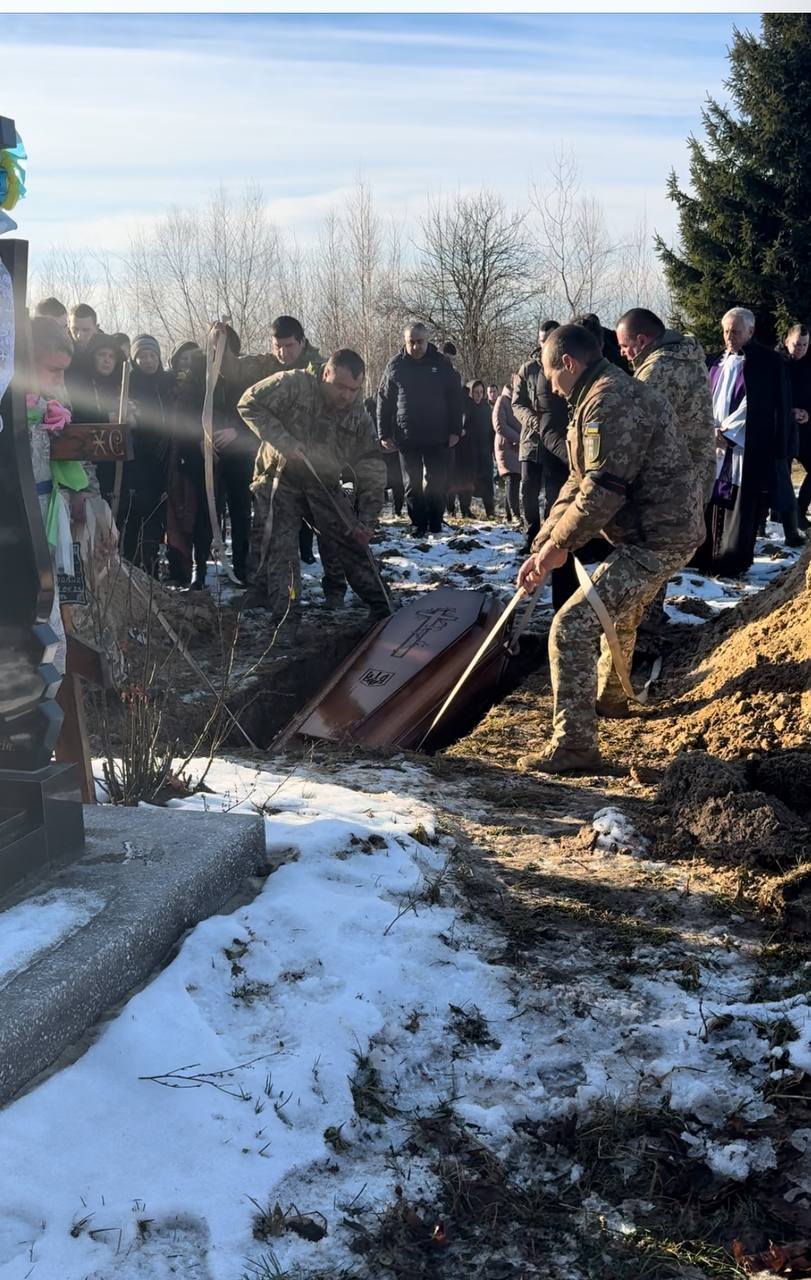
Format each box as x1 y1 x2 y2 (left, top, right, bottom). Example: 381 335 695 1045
0 890 104 987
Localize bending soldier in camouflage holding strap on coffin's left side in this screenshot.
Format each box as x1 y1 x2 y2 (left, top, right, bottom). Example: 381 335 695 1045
239 349 389 640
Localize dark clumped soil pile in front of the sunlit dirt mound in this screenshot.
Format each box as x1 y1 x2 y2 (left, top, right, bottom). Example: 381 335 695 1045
654 751 811 872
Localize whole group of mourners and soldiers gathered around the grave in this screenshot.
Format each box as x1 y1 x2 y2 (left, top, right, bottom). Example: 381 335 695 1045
27 290 811 772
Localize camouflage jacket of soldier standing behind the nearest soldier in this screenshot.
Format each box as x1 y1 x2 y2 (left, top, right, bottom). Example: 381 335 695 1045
632 329 715 503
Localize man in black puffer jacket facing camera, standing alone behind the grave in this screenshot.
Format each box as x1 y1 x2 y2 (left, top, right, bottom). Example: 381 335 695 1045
377 324 462 538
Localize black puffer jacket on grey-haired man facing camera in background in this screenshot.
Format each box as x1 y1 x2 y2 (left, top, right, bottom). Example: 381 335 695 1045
377 342 462 449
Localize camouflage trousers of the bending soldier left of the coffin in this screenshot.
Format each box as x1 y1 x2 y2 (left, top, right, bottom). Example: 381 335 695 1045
249 479 388 621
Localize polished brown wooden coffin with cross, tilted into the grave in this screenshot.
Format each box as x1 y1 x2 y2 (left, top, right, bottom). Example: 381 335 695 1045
274 588 508 748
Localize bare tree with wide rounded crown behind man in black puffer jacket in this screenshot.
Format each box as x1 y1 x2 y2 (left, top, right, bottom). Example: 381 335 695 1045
408 189 533 376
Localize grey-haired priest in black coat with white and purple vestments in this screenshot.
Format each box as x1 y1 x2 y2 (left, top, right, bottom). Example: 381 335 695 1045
693 307 793 577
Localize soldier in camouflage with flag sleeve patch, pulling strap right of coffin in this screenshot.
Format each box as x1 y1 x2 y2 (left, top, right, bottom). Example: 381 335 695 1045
518 325 704 773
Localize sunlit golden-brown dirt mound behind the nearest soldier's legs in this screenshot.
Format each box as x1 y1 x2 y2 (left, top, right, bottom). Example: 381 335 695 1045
448 548 811 773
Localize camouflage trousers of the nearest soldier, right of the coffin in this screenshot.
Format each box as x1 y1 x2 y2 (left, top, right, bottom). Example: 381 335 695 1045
549 547 692 749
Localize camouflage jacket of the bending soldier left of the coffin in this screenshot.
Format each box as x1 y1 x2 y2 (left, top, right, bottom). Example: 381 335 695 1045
238 369 386 526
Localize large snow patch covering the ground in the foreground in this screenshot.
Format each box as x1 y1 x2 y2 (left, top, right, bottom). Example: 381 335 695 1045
0 760 811 1280
